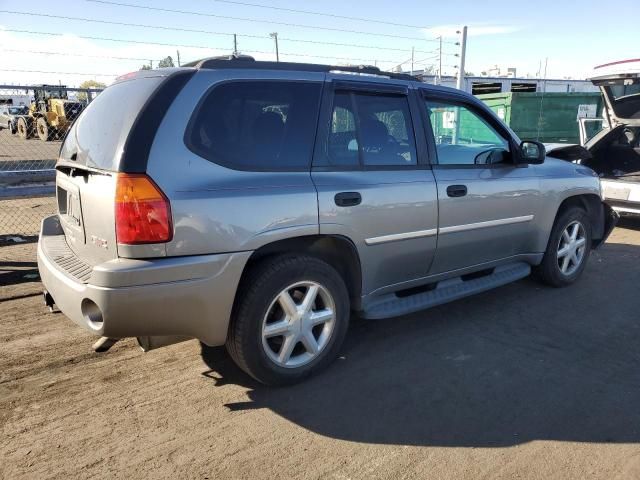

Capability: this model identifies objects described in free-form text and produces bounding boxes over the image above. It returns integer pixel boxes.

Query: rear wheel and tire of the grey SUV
[226,255,350,385]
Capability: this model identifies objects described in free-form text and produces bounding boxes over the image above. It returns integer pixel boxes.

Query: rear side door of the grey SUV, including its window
[312,78,438,295]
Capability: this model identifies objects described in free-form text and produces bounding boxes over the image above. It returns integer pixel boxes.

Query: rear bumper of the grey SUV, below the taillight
[38,215,251,346]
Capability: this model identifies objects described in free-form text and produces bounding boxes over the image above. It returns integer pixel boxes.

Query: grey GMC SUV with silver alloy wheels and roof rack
[38,57,617,384]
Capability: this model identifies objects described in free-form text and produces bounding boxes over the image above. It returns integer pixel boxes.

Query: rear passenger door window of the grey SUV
[328,92,417,167]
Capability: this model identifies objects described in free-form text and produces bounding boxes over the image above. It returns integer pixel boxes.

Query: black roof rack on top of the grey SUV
[182,55,420,81]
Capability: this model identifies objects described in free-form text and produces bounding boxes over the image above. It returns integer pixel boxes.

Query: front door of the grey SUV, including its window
[422,92,540,274]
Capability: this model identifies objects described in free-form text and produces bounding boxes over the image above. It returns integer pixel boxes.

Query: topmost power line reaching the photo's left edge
[0,10,448,54]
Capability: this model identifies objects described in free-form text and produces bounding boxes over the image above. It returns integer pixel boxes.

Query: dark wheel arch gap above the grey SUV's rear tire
[240,235,362,310]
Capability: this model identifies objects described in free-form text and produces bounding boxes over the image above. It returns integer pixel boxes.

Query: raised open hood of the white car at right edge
[590,58,640,127]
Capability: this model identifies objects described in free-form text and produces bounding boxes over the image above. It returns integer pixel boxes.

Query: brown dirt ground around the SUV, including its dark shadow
[0,221,640,480]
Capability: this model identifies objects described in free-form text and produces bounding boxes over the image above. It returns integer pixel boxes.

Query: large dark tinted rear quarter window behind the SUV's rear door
[188,81,321,170]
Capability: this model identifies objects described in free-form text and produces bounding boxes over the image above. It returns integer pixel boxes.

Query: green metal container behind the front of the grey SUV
[477,92,603,143]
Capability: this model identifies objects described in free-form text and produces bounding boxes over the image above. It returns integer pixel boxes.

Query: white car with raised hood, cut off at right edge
[549,60,640,215]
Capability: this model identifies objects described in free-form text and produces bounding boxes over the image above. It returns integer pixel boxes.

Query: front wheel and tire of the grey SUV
[534,207,592,287]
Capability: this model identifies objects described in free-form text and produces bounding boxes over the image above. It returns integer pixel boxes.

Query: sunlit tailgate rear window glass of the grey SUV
[60,77,166,171]
